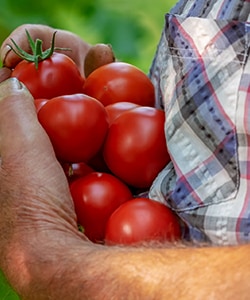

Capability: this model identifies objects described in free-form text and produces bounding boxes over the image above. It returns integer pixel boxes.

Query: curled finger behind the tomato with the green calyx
[0,24,91,74]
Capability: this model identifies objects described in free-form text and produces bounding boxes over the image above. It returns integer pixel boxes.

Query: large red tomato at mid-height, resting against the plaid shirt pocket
[103,107,170,188]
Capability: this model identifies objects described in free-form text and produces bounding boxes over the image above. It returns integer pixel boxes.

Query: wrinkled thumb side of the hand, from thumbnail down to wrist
[0,78,87,299]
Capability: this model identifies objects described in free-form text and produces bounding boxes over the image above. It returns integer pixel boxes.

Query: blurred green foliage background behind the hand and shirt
[0,0,177,300]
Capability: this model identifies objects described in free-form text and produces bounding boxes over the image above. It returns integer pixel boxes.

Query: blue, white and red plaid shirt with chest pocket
[149,0,250,245]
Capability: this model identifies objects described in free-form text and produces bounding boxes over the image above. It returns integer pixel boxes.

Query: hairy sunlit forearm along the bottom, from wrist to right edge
[3,237,250,300]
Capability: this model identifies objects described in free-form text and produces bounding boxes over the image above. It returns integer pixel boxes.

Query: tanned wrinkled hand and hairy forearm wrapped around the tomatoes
[0,25,250,300]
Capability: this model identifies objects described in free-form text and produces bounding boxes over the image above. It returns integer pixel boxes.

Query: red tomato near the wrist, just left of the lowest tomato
[70,172,133,242]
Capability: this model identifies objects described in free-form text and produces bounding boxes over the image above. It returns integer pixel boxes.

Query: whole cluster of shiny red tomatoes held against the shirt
[12,33,181,245]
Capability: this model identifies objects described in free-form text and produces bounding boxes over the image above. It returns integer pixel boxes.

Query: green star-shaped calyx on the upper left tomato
[9,30,70,69]
